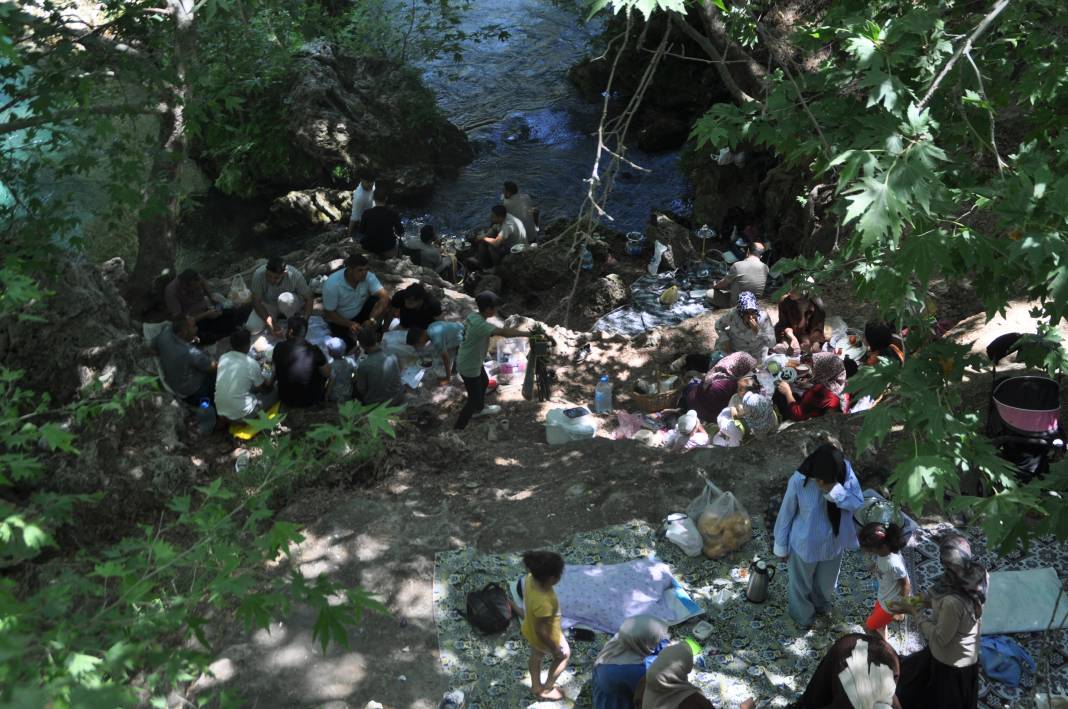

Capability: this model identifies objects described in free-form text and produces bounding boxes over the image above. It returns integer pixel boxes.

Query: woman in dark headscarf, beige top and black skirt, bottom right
[897,533,989,709]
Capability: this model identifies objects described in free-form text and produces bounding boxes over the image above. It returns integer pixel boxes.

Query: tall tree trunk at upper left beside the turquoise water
[126,0,194,314]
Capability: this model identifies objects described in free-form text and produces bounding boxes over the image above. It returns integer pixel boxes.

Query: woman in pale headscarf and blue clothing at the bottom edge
[593,615,668,709]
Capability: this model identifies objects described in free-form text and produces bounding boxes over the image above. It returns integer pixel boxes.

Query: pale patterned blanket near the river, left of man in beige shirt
[594,273,714,337]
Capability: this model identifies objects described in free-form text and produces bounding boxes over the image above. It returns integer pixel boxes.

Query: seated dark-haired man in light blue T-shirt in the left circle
[323,253,390,348]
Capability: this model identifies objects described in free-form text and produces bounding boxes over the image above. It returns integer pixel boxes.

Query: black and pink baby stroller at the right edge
[986,332,1065,483]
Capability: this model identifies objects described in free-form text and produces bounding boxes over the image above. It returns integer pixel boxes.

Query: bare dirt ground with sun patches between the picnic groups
[187,245,1063,709]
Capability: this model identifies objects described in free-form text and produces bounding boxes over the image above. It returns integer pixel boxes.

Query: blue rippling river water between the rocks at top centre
[412,0,690,231]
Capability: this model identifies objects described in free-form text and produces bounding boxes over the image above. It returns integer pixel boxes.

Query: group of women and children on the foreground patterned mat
[517,441,989,709]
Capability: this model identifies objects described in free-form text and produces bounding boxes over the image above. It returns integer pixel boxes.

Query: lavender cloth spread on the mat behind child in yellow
[509,558,704,635]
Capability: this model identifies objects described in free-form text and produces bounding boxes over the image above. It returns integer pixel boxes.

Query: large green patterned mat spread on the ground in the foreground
[434,518,921,709]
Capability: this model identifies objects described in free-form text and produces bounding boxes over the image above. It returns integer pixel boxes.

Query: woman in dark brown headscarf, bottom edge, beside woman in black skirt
[788,633,901,709]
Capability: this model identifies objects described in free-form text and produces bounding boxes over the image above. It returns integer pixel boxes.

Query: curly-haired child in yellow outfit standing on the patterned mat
[522,551,571,699]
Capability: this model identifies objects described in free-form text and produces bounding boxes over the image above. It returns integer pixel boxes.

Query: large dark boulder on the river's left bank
[277,42,474,196]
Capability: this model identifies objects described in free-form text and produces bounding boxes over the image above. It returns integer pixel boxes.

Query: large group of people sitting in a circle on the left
[153,248,480,422]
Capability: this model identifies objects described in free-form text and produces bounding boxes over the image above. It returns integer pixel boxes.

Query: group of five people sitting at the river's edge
[348,175,540,278]
